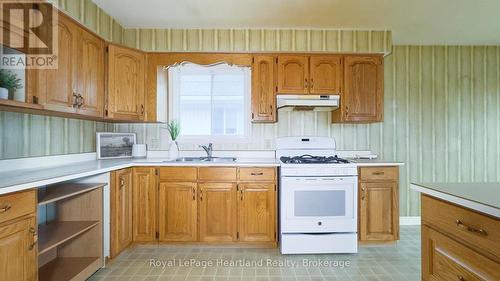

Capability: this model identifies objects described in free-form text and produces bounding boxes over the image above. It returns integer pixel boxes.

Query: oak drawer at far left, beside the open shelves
[0,190,36,223]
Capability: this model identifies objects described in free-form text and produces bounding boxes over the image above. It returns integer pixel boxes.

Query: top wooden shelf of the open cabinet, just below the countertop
[38,183,106,205]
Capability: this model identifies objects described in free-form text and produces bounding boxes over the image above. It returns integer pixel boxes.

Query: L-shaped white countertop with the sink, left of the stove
[0,158,279,194]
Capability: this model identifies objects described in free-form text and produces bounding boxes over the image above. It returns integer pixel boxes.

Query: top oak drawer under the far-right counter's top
[422,195,500,260]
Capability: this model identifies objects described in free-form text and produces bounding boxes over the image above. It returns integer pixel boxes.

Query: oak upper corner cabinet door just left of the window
[107,45,146,121]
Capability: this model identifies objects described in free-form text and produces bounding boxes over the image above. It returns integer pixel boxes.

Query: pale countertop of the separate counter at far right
[411,183,500,218]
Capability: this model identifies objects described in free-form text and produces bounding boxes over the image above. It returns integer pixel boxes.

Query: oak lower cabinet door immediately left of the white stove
[238,183,276,242]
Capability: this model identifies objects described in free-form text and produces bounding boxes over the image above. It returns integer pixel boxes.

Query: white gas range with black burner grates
[276,137,358,254]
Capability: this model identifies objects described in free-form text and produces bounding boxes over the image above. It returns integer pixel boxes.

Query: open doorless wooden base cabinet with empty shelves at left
[38,183,105,281]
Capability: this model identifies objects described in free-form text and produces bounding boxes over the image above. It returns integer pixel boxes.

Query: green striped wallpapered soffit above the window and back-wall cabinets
[123,29,392,54]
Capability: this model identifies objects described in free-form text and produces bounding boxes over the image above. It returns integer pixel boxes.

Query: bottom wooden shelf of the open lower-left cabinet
[38,257,102,281]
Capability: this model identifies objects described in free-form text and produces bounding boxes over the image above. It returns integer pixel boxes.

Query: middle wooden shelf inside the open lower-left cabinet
[38,221,99,255]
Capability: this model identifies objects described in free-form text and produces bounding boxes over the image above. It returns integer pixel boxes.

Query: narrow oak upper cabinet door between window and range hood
[252,56,276,122]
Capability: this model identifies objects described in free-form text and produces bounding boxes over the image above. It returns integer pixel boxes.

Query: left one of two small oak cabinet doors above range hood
[278,55,309,94]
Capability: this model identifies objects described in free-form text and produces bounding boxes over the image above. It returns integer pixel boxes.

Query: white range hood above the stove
[277,94,340,111]
